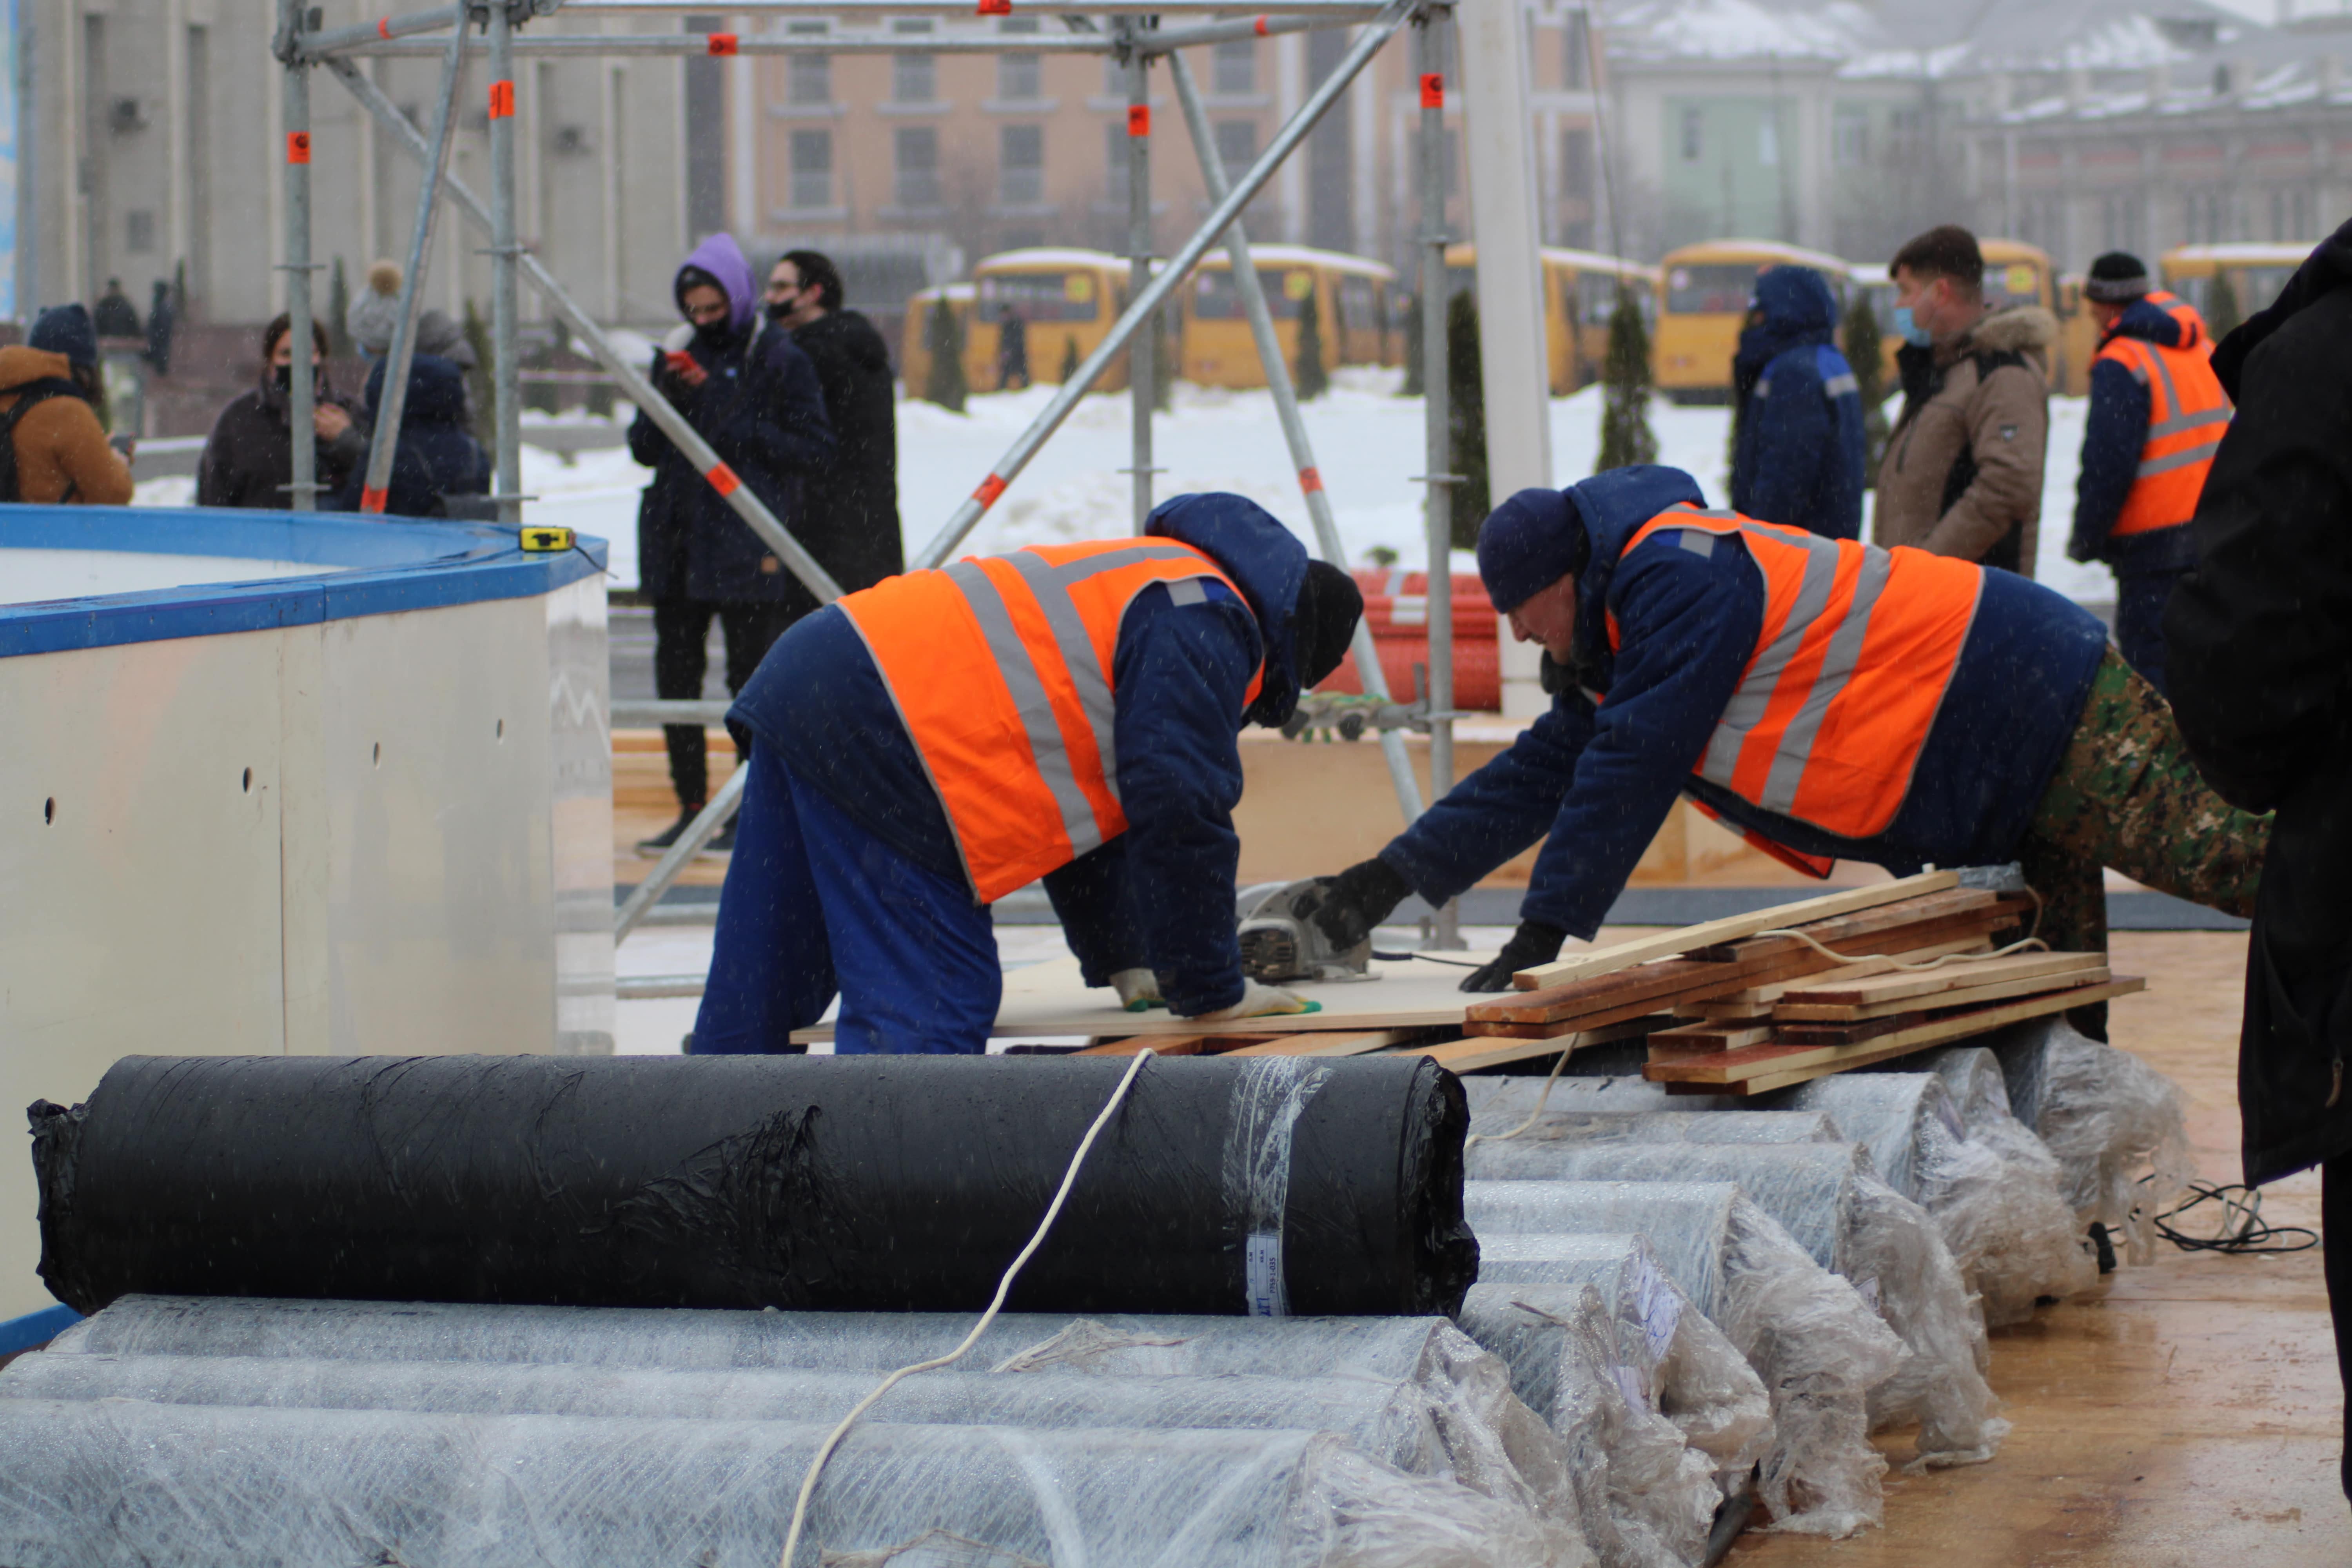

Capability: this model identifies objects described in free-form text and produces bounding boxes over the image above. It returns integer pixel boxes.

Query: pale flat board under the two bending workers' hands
[793,952,1494,1044]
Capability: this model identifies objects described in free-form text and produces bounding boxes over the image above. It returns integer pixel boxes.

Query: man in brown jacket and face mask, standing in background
[1870,223,2058,576]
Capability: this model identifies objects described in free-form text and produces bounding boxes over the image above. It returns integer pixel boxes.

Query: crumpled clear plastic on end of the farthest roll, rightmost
[1985,1018,2197,1262]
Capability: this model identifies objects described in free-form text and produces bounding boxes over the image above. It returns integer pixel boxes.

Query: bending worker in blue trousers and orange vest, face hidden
[689,496,1364,1053]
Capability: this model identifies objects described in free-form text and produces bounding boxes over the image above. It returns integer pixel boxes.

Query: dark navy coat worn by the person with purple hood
[628,318,833,611]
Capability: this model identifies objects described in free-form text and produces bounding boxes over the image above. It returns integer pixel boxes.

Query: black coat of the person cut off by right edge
[2164,223,2352,1182]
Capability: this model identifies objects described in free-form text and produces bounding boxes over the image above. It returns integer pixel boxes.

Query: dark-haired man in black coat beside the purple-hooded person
[767,252,906,592]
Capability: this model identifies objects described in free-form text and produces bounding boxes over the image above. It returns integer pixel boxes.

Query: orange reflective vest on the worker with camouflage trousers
[1609,505,1985,839]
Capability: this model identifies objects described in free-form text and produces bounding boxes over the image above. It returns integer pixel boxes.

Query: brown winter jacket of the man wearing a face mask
[1870,306,2058,576]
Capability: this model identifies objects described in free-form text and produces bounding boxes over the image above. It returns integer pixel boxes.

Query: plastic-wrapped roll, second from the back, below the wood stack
[1778,1067,2098,1326]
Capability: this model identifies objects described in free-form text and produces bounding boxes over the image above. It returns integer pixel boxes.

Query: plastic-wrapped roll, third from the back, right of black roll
[1465,1143,2009,1465]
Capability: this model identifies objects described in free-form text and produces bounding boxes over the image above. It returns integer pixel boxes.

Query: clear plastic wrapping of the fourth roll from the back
[1463,1182,1905,1535]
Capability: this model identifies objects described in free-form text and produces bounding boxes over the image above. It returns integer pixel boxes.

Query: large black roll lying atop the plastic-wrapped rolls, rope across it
[31,1056,1477,1314]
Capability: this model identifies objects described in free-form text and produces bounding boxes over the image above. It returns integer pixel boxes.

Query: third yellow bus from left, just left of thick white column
[1176,245,1397,388]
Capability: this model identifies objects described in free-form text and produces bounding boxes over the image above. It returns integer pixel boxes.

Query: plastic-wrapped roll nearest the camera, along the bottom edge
[0,1399,1592,1568]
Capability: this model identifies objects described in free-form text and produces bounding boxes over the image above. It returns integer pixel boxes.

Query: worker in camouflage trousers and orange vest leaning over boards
[1315,468,2263,1006]
